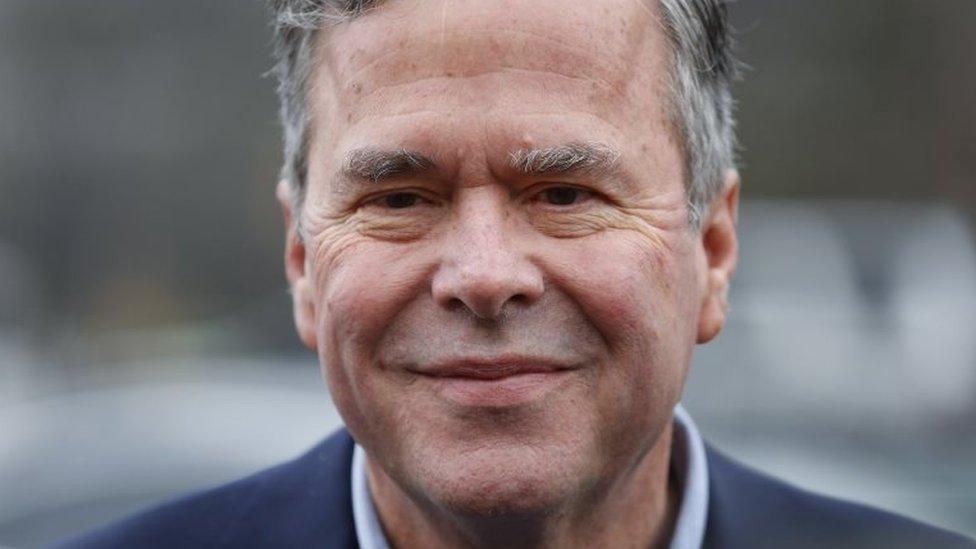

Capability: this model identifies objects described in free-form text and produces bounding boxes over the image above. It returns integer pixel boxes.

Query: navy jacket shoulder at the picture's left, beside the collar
[55,430,356,549]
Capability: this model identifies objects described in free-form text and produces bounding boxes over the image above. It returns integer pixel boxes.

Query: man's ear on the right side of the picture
[698,170,739,343]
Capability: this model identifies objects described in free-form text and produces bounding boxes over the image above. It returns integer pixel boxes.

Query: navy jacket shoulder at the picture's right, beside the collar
[704,446,976,549]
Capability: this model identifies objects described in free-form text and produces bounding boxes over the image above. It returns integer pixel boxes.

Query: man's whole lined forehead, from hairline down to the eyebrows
[310,0,669,170]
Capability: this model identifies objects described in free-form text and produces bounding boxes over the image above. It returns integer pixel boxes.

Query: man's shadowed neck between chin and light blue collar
[366,424,679,549]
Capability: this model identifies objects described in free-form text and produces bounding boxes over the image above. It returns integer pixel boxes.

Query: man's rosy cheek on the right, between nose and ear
[550,227,699,390]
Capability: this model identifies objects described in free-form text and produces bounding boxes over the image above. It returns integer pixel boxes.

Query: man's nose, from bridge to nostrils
[431,192,544,320]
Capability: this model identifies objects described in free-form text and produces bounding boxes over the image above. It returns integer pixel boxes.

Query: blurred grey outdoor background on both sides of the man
[0,0,976,547]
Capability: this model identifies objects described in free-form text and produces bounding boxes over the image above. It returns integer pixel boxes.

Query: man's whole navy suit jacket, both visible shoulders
[59,430,976,549]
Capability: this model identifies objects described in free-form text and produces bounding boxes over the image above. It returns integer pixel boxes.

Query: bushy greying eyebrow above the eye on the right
[509,142,620,175]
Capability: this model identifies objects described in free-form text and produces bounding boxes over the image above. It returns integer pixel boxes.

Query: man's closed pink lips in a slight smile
[415,356,574,408]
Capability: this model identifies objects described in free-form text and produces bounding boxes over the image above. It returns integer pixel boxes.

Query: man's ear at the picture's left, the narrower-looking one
[275,180,317,351]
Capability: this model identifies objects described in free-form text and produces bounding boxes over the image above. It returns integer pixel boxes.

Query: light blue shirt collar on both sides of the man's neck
[351,404,708,549]
